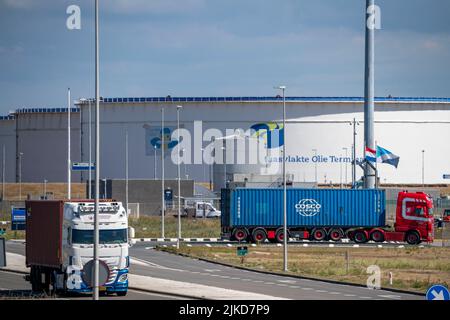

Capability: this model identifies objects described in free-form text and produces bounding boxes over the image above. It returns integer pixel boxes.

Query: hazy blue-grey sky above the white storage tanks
[0,0,450,114]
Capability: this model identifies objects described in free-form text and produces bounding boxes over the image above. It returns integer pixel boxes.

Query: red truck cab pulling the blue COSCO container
[386,191,434,244]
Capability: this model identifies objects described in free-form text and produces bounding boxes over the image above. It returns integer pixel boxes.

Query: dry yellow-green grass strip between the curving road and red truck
[159,246,450,292]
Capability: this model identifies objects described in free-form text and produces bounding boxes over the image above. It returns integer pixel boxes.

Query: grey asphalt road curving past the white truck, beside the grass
[0,242,424,300]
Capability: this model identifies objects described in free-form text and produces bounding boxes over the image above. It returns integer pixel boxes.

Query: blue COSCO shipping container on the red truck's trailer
[222,188,386,228]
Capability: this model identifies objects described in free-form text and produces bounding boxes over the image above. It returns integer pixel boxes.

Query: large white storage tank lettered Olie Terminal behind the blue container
[72,97,450,184]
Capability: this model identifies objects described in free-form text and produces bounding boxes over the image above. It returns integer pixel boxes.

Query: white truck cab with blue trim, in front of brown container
[62,201,134,296]
